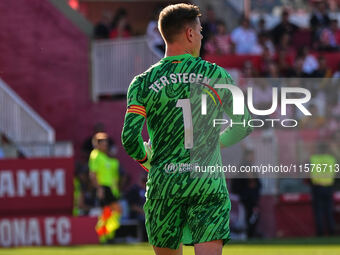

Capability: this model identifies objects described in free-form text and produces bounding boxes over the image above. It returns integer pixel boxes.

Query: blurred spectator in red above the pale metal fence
[110,8,131,39]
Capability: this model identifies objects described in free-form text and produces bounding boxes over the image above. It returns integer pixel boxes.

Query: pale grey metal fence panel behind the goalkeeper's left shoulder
[92,37,159,101]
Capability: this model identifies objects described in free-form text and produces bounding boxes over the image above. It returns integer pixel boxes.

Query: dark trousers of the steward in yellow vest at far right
[312,185,335,236]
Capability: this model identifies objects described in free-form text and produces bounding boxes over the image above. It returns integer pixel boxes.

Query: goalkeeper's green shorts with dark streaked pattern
[144,194,231,249]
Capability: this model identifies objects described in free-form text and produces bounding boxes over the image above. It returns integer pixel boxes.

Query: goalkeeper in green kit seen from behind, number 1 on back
[122,4,252,255]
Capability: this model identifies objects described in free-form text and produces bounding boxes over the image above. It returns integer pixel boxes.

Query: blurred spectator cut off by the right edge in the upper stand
[318,20,339,51]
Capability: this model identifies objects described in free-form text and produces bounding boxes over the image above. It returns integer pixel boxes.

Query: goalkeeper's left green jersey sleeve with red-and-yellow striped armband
[121,78,147,163]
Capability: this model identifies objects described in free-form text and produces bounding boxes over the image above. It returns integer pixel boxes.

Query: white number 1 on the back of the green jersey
[176,99,194,149]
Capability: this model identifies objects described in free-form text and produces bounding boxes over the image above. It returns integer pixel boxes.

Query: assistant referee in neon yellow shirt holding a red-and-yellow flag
[89,132,121,242]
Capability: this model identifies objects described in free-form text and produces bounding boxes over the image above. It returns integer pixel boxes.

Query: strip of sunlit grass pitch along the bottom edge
[0,238,340,255]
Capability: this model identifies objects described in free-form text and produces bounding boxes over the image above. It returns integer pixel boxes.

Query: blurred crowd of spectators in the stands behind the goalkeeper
[94,1,340,138]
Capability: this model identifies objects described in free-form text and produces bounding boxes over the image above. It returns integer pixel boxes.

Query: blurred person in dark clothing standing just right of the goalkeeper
[232,150,261,238]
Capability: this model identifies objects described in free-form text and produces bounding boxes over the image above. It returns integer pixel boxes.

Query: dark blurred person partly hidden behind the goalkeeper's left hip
[126,172,147,241]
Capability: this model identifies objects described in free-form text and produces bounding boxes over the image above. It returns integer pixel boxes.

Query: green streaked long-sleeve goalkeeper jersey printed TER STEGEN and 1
[122,54,251,198]
